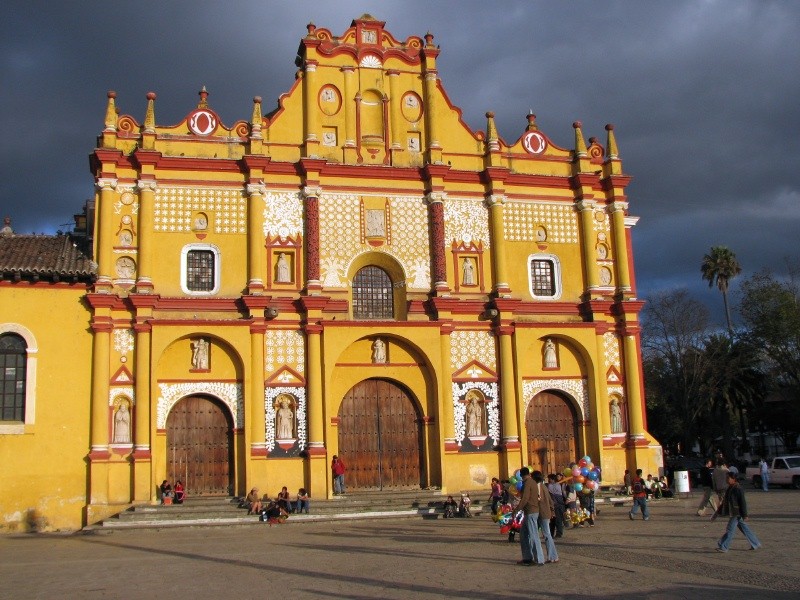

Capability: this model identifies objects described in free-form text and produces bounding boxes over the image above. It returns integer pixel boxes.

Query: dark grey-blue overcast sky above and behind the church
[0,0,800,323]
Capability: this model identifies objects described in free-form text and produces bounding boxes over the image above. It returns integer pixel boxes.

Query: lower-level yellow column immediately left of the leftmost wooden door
[133,317,156,502]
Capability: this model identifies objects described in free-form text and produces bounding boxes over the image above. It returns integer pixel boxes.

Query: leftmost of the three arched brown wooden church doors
[167,396,233,496]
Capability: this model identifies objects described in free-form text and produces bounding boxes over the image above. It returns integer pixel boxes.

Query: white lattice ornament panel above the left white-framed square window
[153,187,247,234]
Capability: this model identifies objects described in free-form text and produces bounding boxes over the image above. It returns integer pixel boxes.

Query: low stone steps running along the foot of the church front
[84,490,489,531]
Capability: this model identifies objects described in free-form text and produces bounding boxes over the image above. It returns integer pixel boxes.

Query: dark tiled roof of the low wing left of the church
[0,235,97,281]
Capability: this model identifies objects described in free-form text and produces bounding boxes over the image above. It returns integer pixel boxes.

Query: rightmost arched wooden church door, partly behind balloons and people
[525,392,578,475]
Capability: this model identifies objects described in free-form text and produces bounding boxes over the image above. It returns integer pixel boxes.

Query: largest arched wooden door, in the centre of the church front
[339,379,423,489]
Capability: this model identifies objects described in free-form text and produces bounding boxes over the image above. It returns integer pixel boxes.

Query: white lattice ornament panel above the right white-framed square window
[503,202,578,244]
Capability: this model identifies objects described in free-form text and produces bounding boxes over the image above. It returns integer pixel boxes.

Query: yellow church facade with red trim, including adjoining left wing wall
[0,15,661,529]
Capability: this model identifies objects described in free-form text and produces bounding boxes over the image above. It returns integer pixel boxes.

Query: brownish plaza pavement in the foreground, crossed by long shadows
[0,486,800,600]
